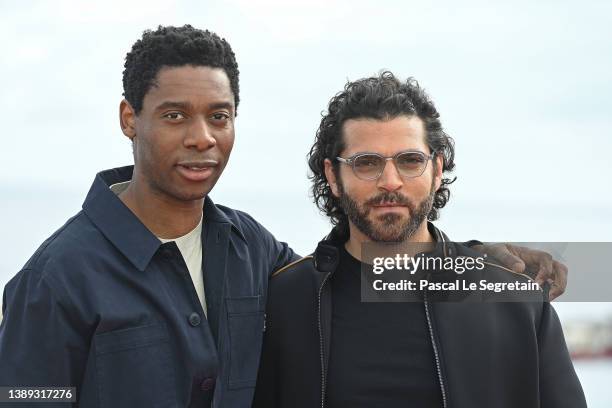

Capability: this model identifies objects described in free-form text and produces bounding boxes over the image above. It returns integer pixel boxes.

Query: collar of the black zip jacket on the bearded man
[313,221,457,272]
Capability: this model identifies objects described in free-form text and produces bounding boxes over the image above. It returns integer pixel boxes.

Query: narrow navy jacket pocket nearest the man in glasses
[226,296,264,389]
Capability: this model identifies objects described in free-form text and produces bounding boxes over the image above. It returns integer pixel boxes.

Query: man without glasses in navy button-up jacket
[0,25,572,408]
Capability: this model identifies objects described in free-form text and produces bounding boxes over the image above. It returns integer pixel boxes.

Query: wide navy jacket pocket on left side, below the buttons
[94,324,176,408]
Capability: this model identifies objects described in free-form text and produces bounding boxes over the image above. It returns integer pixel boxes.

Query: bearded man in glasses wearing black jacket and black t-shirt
[254,72,586,408]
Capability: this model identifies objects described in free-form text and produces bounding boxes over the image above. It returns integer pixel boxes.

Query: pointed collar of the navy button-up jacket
[83,166,244,271]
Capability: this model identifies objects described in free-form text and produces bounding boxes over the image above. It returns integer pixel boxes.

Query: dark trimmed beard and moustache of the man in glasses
[338,180,436,243]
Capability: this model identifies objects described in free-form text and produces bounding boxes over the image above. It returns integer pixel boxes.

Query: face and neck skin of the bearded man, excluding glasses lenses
[325,115,442,259]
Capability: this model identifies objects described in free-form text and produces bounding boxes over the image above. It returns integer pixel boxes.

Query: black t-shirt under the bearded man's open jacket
[327,247,442,408]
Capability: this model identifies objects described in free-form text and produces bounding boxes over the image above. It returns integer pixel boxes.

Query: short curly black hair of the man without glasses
[123,24,240,114]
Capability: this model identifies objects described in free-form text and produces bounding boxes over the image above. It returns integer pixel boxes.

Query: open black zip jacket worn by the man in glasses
[254,226,586,408]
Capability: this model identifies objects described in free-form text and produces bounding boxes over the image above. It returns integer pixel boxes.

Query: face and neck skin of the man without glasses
[119,66,235,239]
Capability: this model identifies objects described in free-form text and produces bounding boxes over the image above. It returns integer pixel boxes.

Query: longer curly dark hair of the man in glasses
[307,71,456,234]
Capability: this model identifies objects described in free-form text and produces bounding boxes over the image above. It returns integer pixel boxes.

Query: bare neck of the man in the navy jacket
[119,178,204,239]
